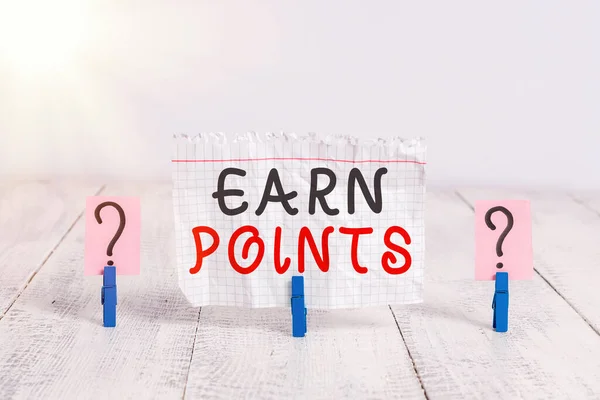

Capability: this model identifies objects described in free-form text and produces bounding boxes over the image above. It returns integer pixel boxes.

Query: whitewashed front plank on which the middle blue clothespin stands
[186,307,424,399]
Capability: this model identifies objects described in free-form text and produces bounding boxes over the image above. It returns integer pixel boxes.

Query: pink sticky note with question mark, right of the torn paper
[475,200,533,280]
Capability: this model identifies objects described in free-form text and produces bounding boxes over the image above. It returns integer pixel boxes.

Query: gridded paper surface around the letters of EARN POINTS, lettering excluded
[173,141,425,309]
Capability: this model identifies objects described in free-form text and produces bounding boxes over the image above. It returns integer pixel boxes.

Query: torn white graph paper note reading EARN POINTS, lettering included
[172,134,425,309]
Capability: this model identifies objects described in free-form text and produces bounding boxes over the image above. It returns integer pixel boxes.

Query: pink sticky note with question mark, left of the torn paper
[85,196,141,275]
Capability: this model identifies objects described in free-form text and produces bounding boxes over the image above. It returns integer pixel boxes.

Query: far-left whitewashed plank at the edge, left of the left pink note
[0,181,101,318]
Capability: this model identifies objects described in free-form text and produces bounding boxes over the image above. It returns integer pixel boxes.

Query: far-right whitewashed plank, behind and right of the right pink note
[460,189,600,335]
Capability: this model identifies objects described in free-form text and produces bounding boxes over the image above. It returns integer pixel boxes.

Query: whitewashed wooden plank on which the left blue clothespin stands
[0,185,199,399]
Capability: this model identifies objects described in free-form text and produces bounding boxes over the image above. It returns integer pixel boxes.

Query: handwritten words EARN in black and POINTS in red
[190,167,412,275]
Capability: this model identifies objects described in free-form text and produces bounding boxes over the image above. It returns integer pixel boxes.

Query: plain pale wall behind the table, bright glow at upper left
[0,0,600,188]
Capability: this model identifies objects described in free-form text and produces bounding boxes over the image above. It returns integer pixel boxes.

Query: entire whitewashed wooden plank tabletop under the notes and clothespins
[0,181,600,399]
